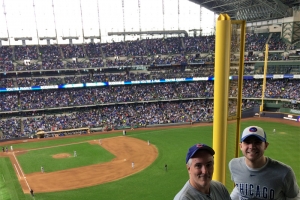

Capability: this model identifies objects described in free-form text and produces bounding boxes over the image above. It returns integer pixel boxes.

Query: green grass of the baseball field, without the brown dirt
[0,121,300,200]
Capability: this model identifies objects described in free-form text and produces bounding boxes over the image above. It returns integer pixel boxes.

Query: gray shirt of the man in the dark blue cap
[174,181,231,200]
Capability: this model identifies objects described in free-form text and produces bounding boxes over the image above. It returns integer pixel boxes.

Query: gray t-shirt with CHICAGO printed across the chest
[229,157,299,200]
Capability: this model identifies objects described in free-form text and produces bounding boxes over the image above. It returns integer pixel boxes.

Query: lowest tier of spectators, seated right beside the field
[0,99,257,139]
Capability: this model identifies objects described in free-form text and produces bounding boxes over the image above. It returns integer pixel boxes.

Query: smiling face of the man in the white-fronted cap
[240,136,268,162]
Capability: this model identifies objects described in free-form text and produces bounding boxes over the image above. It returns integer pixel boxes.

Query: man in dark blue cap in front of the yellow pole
[174,143,231,200]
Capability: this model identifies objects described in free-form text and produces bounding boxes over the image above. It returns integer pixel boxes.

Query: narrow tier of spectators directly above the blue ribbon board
[0,63,291,88]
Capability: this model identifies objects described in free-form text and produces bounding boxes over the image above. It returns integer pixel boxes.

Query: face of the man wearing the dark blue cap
[187,150,214,193]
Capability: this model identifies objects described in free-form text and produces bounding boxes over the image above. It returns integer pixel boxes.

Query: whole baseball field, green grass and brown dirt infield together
[0,118,300,200]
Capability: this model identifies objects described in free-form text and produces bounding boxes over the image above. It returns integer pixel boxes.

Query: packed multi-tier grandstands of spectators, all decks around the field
[0,33,300,139]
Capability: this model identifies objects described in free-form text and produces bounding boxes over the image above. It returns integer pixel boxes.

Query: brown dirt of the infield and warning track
[0,118,300,193]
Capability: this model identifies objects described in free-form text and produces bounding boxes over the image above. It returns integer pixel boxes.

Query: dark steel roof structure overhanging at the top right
[189,0,300,22]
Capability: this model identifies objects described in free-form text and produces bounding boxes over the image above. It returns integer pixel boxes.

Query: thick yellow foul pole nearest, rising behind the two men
[213,14,231,184]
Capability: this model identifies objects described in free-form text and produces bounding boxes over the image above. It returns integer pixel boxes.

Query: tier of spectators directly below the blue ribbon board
[0,79,300,112]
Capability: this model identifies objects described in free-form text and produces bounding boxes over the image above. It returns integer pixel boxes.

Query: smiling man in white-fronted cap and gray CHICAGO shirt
[229,126,300,200]
